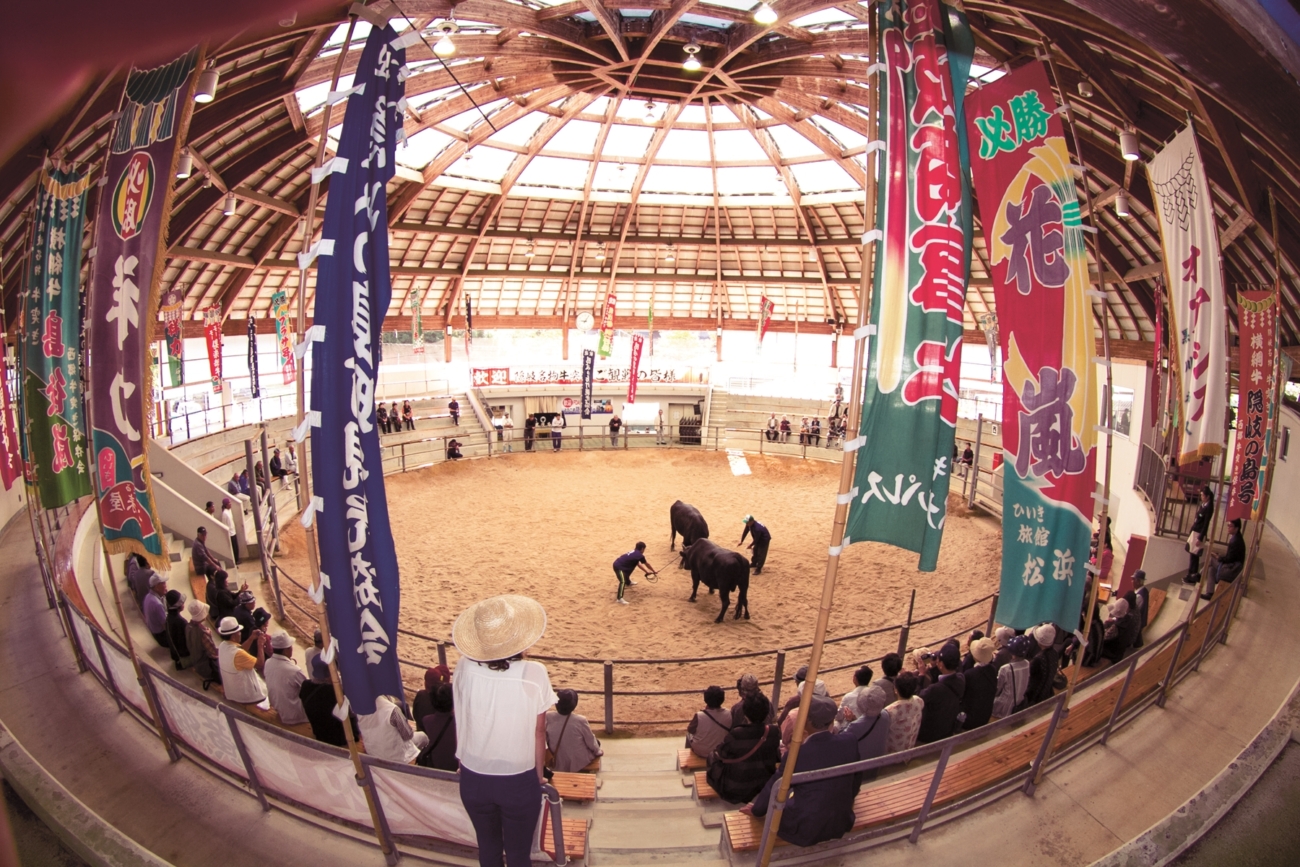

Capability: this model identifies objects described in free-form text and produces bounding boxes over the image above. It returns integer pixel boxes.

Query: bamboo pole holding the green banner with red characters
[757,4,884,867]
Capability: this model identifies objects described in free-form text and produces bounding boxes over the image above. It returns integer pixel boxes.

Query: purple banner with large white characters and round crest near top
[86,51,198,569]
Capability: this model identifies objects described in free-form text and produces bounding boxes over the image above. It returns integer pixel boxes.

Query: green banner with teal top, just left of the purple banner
[21,168,90,508]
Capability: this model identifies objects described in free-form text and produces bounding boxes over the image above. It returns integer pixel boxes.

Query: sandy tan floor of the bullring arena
[278,450,1001,733]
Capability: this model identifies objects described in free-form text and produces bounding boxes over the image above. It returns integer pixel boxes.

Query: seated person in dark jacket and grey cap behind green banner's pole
[741,695,858,846]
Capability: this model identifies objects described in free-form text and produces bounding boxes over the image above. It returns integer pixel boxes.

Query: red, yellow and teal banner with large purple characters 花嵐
[966,62,1099,629]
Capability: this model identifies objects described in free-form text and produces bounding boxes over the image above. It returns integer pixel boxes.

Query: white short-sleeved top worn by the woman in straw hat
[452,659,558,776]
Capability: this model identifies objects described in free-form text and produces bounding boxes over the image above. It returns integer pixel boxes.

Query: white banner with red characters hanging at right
[1147,123,1227,465]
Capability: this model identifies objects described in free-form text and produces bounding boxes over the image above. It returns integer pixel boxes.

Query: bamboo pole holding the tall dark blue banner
[282,14,397,864]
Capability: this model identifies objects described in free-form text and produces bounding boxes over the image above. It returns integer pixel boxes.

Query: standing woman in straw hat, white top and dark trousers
[451,595,558,867]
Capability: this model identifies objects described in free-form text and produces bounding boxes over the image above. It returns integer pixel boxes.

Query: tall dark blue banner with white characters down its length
[304,26,408,714]
